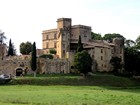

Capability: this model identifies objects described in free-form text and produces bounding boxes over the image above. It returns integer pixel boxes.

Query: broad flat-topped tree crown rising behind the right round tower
[103,33,125,42]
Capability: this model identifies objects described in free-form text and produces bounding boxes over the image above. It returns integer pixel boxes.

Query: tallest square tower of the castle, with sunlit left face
[57,18,71,58]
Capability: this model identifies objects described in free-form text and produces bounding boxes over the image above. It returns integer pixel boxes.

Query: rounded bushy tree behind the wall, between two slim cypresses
[20,41,32,55]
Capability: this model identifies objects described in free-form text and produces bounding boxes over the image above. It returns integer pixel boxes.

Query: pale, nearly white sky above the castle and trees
[0,0,140,54]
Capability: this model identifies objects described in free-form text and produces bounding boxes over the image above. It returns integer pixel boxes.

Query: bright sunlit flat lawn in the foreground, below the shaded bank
[0,85,140,105]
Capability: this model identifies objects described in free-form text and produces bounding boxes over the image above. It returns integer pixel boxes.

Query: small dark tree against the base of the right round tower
[110,57,122,75]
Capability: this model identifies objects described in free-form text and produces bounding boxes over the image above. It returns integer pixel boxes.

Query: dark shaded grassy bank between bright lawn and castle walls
[9,74,140,87]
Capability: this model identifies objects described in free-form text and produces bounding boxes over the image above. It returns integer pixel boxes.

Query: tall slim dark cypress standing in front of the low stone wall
[31,42,37,77]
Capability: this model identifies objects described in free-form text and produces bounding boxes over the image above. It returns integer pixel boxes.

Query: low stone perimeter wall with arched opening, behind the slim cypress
[0,56,70,76]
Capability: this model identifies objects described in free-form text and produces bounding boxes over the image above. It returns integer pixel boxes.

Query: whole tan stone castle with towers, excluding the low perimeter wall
[42,18,124,71]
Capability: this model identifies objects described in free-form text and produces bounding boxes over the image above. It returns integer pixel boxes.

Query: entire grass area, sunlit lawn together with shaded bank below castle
[0,75,140,105]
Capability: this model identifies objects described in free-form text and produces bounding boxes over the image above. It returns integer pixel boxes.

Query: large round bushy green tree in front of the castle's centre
[74,50,92,75]
